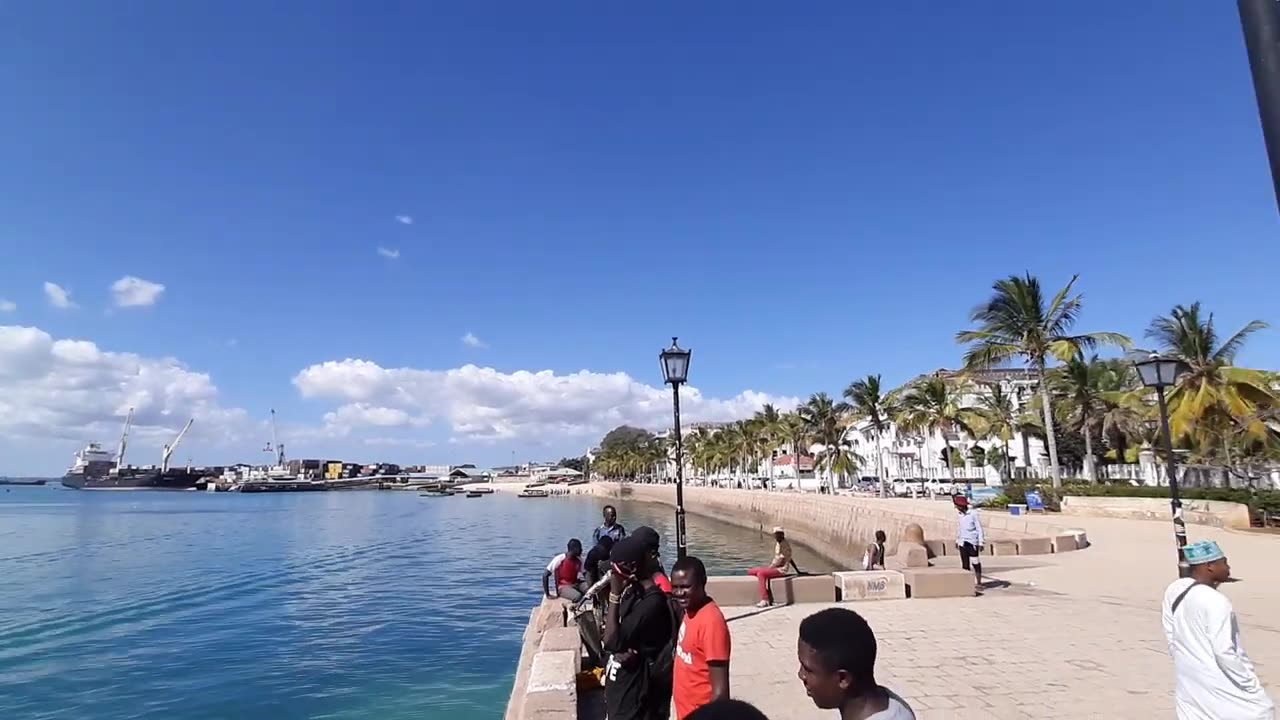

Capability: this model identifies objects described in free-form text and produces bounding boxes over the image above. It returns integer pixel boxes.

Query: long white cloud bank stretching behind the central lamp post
[293,359,799,441]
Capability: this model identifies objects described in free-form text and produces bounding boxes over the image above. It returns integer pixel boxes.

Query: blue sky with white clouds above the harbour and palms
[0,1,1280,473]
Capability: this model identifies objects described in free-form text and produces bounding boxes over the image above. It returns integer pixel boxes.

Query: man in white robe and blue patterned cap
[1161,541,1275,720]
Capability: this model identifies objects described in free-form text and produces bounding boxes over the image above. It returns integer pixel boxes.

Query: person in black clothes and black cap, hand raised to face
[604,537,676,720]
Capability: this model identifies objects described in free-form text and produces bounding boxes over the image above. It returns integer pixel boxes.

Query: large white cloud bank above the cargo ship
[0,325,256,450]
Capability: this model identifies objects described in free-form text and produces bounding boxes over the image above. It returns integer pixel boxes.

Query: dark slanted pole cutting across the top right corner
[1236,0,1280,209]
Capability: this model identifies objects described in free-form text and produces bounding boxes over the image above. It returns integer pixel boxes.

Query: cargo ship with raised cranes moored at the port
[63,409,206,489]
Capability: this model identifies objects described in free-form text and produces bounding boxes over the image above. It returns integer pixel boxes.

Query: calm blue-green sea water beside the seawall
[0,487,827,720]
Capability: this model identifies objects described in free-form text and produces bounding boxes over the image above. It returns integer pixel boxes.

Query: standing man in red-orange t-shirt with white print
[671,556,731,720]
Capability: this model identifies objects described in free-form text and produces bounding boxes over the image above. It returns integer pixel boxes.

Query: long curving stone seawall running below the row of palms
[586,483,1088,568]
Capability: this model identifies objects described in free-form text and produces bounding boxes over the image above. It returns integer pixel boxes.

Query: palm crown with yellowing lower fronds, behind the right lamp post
[1147,302,1276,445]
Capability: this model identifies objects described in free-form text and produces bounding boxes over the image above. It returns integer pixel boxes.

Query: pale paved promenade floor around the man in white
[604,489,1280,720]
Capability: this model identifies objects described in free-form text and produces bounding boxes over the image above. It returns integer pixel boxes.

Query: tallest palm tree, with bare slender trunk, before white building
[956,273,1132,487]
